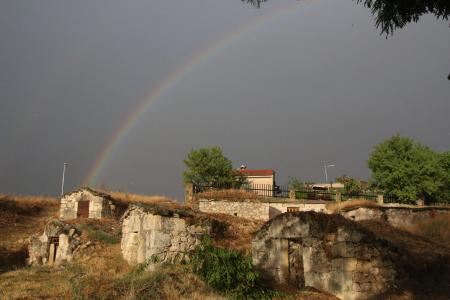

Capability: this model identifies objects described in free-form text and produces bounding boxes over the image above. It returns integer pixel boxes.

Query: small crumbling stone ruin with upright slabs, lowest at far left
[28,220,81,265]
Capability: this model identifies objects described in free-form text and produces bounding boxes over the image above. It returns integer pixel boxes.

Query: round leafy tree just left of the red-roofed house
[183,147,238,187]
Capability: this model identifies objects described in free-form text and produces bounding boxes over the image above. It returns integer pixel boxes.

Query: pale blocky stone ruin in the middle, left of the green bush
[121,204,214,264]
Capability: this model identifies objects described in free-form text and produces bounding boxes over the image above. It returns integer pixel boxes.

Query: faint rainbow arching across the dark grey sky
[83,1,306,185]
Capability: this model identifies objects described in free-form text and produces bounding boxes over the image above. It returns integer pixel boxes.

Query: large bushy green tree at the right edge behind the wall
[368,134,450,202]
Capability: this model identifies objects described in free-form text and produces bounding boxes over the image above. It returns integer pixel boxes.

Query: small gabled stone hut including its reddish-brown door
[60,188,125,220]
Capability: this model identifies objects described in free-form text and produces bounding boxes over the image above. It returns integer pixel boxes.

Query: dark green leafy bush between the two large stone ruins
[190,236,276,299]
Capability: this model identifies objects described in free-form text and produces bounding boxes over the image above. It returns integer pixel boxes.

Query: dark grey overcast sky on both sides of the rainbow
[0,0,450,199]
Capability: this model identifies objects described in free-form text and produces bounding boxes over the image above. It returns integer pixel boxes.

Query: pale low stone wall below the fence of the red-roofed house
[198,199,269,221]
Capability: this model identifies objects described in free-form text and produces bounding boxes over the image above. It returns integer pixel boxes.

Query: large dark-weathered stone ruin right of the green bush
[252,212,398,300]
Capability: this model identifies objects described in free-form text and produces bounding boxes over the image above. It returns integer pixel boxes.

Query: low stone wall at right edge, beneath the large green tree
[341,207,450,227]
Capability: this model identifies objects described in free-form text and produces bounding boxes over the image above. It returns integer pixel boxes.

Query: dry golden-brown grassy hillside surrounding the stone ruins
[0,192,450,300]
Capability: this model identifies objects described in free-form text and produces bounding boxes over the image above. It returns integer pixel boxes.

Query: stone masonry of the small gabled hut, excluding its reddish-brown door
[60,188,117,220]
